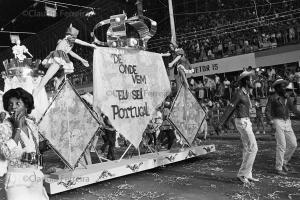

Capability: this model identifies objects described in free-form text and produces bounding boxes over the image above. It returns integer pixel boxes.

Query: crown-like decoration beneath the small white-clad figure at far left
[1,58,44,78]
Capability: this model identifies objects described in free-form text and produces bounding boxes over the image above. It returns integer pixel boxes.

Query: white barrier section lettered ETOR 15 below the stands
[187,53,256,77]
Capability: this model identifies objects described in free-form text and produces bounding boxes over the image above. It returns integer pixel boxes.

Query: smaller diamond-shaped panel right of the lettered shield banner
[169,87,206,144]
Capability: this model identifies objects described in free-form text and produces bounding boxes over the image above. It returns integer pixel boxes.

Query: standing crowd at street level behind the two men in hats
[189,63,300,134]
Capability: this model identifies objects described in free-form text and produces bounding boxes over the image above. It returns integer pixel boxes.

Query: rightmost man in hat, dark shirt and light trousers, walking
[266,78,300,175]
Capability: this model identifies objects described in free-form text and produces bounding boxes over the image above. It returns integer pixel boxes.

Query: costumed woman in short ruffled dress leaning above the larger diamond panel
[33,24,97,96]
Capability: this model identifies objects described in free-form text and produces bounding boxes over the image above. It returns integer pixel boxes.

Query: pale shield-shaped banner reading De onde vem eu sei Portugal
[93,47,171,147]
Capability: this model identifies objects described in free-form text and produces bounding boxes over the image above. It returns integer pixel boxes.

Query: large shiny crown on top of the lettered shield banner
[92,14,157,50]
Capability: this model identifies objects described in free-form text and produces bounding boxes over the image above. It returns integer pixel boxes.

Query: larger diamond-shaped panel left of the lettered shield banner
[39,81,99,168]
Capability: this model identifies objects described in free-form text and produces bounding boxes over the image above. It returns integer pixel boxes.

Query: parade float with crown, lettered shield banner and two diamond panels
[1,11,215,194]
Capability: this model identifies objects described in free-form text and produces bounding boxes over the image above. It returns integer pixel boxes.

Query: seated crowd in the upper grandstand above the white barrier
[149,0,300,63]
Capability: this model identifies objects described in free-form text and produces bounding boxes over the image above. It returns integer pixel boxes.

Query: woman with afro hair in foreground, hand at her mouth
[0,88,49,200]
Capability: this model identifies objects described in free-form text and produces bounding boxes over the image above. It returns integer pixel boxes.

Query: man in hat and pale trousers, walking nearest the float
[221,70,259,184]
